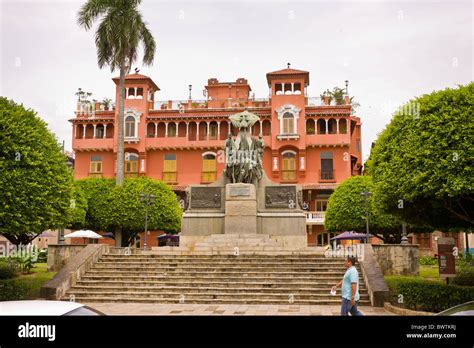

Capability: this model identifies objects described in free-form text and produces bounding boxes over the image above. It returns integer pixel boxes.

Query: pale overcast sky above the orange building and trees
[0,0,473,159]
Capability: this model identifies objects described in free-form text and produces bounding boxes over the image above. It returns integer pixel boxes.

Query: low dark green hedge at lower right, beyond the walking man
[386,277,474,312]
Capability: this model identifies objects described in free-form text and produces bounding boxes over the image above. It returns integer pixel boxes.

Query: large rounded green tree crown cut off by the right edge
[370,83,474,230]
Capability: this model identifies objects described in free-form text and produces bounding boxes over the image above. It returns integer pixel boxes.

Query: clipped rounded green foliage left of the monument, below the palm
[78,177,181,246]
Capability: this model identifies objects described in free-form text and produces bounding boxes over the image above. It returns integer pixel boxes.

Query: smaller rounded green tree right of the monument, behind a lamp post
[324,176,401,243]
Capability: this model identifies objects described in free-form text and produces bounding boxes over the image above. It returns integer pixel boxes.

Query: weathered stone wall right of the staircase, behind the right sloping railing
[372,244,419,276]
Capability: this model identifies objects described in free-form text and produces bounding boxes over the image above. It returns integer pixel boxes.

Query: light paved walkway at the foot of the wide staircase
[86,303,395,315]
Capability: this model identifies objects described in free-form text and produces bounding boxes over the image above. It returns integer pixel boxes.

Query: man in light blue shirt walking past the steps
[332,256,363,316]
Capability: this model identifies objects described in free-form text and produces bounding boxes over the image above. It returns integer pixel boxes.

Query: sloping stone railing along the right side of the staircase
[359,244,390,307]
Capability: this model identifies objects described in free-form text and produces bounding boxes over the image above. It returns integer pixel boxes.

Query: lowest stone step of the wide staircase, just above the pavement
[65,296,370,306]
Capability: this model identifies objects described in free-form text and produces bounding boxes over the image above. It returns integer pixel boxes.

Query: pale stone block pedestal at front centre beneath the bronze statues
[224,184,258,234]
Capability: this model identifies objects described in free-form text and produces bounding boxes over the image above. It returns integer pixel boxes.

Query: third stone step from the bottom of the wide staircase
[77,279,365,290]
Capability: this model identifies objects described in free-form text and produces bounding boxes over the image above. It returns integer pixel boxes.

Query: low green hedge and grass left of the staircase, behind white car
[0,263,56,301]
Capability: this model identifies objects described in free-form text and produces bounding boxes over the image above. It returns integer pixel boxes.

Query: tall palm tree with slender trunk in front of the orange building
[77,0,156,185]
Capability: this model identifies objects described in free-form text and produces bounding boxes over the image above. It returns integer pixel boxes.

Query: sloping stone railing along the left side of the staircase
[40,244,109,300]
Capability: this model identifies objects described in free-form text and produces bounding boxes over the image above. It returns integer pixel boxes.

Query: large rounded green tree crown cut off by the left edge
[0,98,72,244]
